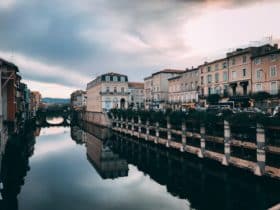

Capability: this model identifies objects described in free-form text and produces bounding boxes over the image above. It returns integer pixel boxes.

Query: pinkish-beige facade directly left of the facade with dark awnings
[198,58,228,96]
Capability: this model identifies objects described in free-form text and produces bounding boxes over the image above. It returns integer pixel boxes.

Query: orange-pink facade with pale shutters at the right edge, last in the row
[252,50,280,95]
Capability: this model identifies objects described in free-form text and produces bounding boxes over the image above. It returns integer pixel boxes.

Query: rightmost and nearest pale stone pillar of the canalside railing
[254,123,266,176]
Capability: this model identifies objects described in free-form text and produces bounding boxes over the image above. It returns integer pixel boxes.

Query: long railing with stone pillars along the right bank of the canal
[112,116,280,179]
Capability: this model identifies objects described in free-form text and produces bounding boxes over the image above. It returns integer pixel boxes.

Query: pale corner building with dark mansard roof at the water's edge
[86,72,129,112]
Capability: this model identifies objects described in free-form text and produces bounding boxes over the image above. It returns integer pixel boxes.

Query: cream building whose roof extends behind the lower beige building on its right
[144,69,184,109]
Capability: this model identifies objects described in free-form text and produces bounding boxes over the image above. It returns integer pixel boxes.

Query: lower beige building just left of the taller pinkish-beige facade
[168,68,199,109]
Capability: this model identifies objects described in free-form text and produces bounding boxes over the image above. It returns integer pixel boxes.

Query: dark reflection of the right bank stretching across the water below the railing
[72,124,280,210]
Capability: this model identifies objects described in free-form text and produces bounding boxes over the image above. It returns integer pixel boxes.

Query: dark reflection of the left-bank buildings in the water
[0,126,37,210]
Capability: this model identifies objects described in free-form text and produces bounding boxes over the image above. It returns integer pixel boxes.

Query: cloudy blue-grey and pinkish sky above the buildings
[0,0,280,98]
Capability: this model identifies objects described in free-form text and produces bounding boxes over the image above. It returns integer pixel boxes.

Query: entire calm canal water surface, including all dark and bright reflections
[0,120,280,210]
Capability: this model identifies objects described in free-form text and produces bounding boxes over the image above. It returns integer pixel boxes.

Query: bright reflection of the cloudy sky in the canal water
[19,128,188,210]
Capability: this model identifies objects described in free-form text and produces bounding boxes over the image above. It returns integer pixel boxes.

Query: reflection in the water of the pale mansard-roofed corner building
[71,124,128,179]
